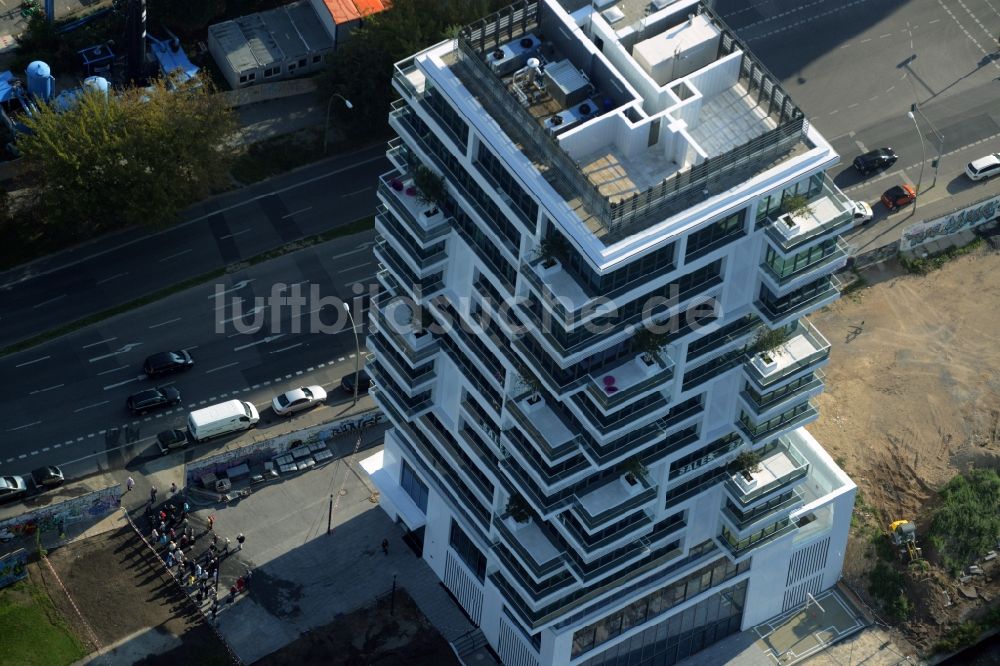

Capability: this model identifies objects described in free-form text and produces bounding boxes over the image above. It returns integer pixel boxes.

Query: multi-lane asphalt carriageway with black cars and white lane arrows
[0,231,375,473]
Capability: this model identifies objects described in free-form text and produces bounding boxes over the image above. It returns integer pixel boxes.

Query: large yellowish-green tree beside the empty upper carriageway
[18,81,236,232]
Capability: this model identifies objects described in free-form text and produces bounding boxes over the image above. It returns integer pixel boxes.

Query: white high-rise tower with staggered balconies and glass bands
[366,0,855,666]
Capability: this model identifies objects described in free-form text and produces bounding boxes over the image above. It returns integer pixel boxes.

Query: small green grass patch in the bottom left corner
[0,577,89,666]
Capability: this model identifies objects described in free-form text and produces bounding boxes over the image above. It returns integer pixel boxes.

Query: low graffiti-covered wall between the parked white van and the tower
[185,409,385,486]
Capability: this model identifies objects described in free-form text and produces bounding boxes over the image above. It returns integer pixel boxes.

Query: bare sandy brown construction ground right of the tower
[809,243,1000,654]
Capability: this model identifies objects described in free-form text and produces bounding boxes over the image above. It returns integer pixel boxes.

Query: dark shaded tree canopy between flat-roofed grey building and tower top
[318,0,510,137]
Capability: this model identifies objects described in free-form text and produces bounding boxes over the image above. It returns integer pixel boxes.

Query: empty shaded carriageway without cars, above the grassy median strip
[0,145,391,346]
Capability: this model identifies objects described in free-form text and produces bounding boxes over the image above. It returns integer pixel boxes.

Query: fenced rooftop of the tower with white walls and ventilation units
[448,2,808,244]
